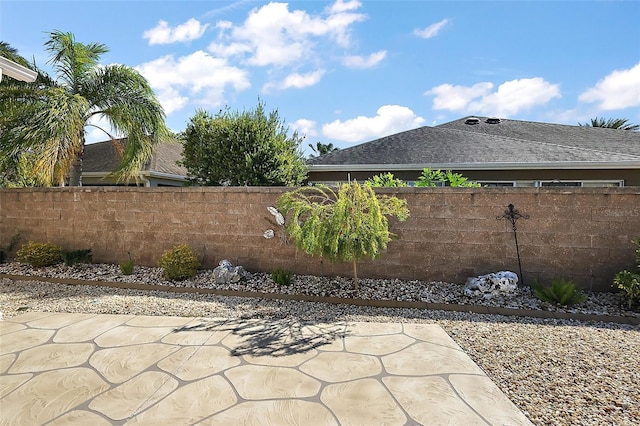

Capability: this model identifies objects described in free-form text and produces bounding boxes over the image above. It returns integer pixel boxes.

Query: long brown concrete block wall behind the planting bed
[0,187,640,291]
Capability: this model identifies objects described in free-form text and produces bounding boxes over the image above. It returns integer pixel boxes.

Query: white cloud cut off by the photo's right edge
[578,62,640,111]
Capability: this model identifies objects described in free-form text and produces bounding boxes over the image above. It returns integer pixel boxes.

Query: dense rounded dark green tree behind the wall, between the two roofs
[182,101,307,186]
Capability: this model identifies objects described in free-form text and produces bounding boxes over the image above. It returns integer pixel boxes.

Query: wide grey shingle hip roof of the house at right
[309,117,640,171]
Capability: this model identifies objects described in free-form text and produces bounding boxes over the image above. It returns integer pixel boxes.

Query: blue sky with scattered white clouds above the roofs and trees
[0,0,640,155]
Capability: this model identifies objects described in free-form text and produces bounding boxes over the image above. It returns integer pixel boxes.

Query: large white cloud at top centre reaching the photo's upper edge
[209,0,365,66]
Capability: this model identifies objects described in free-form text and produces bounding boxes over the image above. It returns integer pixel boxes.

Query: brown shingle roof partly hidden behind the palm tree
[82,140,187,185]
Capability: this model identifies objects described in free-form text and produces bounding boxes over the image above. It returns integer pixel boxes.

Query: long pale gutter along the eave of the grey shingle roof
[308,161,640,172]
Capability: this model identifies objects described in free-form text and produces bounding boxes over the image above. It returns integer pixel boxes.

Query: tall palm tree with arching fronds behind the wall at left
[0,31,171,186]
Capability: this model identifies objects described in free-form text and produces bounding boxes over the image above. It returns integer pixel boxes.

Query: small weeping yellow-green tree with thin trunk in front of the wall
[277,181,409,290]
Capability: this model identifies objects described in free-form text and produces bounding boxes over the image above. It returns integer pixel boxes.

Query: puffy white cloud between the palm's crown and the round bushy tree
[136,51,251,114]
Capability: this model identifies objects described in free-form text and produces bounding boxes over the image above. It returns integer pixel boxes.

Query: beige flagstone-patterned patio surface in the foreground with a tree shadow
[0,312,531,426]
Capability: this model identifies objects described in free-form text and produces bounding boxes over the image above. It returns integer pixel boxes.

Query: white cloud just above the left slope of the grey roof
[322,105,424,142]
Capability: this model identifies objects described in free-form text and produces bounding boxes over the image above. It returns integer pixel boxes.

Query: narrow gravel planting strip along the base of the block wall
[0,262,640,317]
